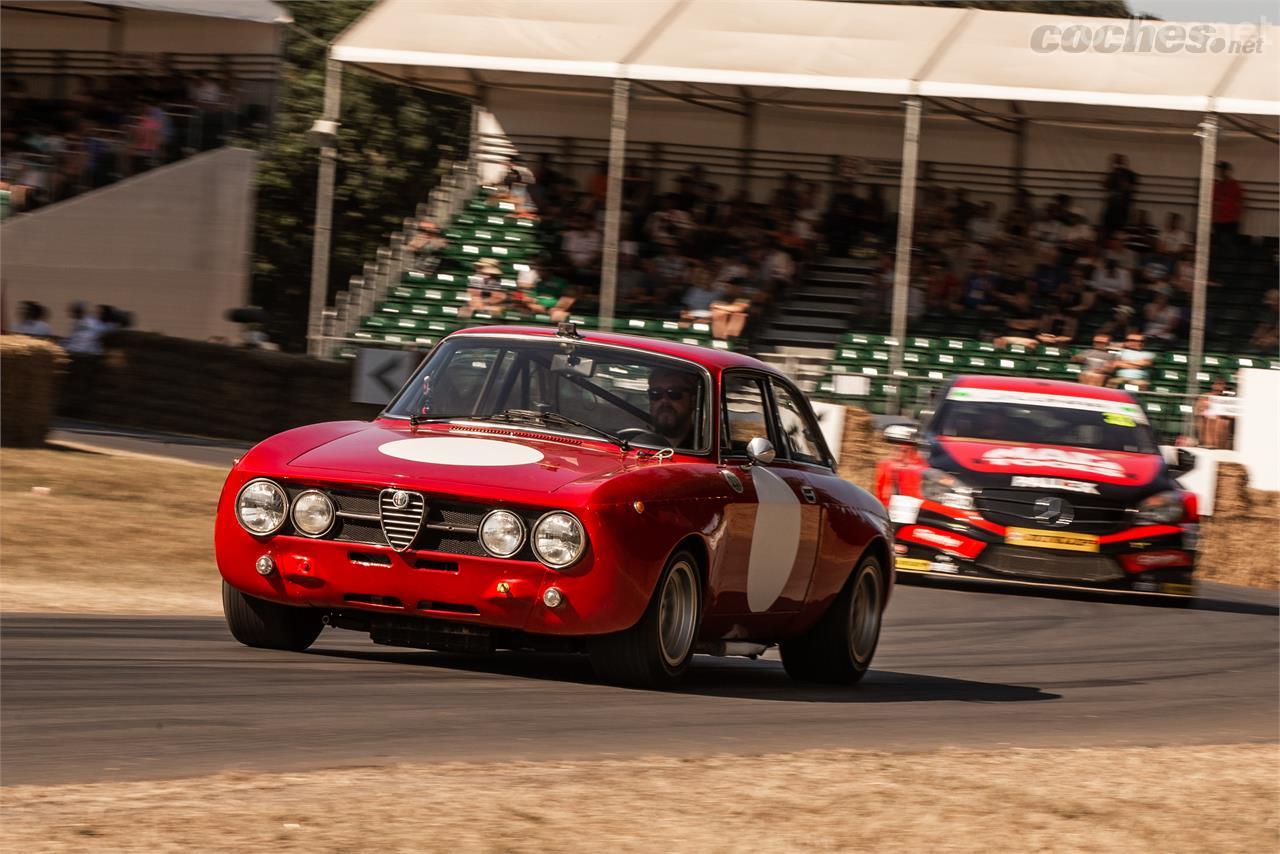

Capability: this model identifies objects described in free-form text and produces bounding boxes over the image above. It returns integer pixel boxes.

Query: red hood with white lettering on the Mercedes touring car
[938,437,1164,487]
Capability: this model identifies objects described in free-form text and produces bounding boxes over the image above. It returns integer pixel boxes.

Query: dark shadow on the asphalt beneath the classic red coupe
[306,648,1061,703]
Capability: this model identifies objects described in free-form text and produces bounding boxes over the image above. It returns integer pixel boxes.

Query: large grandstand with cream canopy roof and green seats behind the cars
[312,0,1280,448]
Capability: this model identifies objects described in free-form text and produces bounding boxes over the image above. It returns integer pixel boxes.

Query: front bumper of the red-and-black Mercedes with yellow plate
[895,502,1198,598]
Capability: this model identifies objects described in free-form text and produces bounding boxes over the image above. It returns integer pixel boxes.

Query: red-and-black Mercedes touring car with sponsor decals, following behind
[877,376,1199,598]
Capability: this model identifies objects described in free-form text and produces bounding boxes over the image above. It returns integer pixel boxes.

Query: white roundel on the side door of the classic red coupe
[746,466,800,612]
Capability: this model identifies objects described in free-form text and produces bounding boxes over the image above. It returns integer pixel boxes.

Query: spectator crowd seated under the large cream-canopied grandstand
[411,148,1275,363]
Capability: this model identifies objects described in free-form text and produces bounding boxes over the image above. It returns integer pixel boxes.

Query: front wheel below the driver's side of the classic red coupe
[588,552,703,688]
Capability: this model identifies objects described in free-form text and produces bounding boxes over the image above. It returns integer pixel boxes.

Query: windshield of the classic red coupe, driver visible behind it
[387,335,709,453]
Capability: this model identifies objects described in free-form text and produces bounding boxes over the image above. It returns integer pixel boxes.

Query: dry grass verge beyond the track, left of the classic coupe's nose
[0,448,227,613]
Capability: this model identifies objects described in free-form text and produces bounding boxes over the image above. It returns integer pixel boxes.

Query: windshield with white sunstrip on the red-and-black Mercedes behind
[929,388,1158,453]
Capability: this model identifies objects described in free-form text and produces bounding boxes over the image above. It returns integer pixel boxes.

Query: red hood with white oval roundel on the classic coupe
[289,424,625,495]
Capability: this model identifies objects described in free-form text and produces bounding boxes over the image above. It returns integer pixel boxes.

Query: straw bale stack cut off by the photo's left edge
[0,335,69,447]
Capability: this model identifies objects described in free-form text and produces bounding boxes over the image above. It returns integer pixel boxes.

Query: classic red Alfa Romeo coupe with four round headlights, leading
[215,324,893,685]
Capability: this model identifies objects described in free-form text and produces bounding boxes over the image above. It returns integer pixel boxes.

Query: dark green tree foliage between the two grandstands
[253,0,470,350]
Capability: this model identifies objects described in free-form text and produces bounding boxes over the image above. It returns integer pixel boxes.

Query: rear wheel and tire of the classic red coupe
[781,557,884,685]
